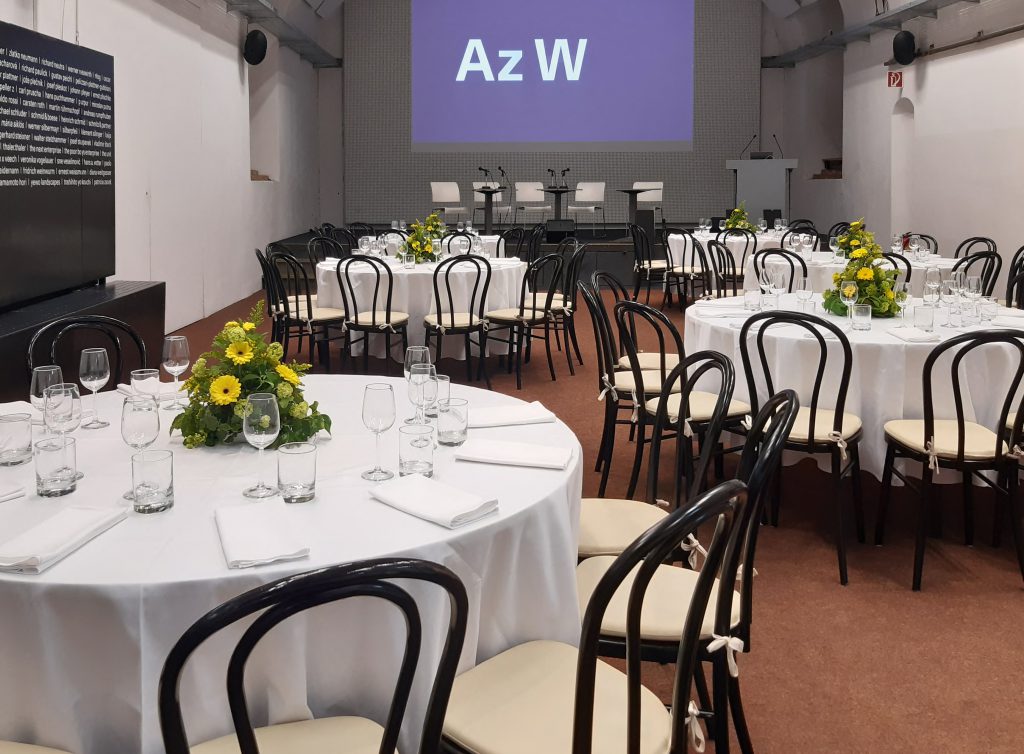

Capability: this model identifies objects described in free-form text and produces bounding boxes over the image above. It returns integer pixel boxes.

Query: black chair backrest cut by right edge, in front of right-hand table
[922,330,1024,463]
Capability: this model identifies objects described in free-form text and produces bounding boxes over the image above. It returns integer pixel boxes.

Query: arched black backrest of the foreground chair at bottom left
[158,557,468,754]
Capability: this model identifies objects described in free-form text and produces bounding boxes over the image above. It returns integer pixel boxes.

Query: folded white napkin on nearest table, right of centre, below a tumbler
[370,474,498,529]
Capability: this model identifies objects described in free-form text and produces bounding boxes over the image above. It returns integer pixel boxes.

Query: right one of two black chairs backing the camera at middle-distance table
[423,254,490,388]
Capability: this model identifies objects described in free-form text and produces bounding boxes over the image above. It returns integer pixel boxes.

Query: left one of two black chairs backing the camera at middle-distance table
[335,254,409,373]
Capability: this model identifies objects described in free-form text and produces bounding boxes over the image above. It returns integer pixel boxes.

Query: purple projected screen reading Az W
[412,0,694,152]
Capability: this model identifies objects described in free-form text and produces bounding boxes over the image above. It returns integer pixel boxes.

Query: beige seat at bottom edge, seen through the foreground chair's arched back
[190,717,384,754]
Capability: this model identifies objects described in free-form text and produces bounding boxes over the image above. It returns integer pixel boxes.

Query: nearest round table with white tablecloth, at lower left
[0,376,582,754]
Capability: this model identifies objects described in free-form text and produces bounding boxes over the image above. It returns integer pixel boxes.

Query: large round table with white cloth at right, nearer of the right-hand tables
[684,294,1024,483]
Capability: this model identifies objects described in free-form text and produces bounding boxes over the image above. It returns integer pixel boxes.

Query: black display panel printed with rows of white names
[0,23,114,309]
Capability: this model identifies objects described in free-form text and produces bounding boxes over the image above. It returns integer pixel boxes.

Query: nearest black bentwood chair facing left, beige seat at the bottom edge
[438,481,746,754]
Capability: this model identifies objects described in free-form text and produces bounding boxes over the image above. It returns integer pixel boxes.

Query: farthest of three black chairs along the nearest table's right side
[578,351,735,559]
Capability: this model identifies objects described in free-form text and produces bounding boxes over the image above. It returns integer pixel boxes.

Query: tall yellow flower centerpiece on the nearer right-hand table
[823,219,906,317]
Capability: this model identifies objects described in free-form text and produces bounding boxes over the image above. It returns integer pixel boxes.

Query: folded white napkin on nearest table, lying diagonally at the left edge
[0,506,128,574]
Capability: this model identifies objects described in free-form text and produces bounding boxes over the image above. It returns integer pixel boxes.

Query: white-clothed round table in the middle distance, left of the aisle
[316,257,526,360]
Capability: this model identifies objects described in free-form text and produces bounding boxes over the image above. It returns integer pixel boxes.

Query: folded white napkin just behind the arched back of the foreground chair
[213,501,309,569]
